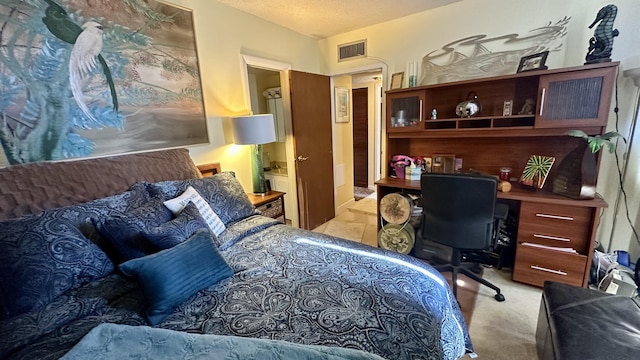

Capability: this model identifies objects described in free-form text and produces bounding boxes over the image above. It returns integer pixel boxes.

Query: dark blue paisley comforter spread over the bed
[0,215,472,359]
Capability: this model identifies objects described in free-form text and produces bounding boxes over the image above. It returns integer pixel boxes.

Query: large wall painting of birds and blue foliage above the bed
[0,0,209,166]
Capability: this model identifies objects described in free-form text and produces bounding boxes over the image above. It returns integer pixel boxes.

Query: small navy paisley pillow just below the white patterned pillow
[142,202,211,250]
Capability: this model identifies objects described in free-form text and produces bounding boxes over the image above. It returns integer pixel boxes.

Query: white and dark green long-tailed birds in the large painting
[42,0,118,122]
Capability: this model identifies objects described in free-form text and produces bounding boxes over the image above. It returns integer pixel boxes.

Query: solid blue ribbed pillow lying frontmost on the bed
[119,230,233,325]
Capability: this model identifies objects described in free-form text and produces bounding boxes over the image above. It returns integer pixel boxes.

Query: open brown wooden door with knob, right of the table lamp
[289,70,335,229]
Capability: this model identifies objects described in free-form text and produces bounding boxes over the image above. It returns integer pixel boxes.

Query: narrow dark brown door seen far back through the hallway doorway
[351,88,369,187]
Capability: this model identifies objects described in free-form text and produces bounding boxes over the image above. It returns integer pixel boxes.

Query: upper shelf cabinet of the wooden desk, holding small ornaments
[386,63,617,137]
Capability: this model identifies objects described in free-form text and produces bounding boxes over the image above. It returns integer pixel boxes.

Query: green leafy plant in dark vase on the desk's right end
[552,130,622,199]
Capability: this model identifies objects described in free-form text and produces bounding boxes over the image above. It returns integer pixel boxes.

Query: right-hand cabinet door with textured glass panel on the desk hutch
[536,67,616,128]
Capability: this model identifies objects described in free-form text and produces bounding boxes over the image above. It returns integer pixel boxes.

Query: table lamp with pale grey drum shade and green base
[231,114,276,195]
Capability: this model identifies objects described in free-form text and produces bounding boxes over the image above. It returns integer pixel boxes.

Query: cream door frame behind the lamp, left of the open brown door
[241,54,300,227]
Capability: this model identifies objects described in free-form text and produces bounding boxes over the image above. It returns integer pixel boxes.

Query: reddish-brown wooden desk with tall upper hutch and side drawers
[376,62,618,286]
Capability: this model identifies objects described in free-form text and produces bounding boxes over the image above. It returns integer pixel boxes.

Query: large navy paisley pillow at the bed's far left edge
[0,207,113,318]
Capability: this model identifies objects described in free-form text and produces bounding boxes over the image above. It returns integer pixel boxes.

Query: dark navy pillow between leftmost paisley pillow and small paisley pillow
[92,198,173,263]
